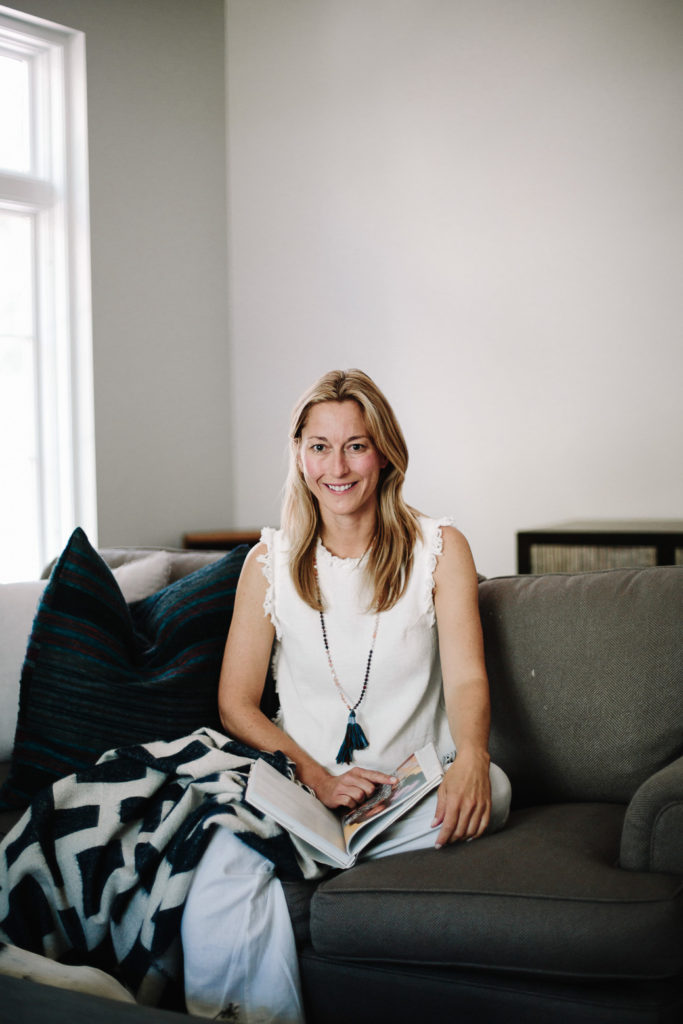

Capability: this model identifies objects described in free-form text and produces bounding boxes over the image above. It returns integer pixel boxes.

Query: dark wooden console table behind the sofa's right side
[517,519,683,572]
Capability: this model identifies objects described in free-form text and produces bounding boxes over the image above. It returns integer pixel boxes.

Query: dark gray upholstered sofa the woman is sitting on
[0,552,683,1024]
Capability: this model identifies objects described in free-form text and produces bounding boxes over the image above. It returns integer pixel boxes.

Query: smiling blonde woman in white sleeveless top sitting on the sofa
[182,370,510,1024]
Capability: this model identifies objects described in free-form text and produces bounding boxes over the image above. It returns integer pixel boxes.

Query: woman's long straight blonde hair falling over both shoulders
[282,370,421,611]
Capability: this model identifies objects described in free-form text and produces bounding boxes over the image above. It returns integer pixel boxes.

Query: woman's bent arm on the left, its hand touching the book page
[218,544,389,808]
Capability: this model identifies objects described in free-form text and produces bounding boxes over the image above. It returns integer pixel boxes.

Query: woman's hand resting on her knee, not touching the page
[432,750,490,850]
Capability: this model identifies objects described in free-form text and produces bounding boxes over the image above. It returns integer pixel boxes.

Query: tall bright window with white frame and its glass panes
[0,7,96,583]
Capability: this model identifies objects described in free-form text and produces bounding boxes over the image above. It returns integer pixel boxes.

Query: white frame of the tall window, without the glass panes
[0,5,97,566]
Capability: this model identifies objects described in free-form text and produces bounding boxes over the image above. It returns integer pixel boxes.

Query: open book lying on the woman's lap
[247,743,443,867]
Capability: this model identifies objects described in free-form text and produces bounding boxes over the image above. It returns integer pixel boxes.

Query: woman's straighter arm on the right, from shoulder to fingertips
[434,526,490,847]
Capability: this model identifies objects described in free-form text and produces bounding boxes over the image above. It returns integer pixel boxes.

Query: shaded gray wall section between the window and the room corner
[17,0,231,546]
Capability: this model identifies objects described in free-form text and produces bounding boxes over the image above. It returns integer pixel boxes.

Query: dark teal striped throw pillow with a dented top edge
[0,528,248,810]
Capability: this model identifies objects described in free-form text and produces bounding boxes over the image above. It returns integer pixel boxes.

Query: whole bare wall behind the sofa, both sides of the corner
[10,0,683,574]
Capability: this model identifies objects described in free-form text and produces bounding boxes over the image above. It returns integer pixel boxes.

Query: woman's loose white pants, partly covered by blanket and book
[181,765,510,1024]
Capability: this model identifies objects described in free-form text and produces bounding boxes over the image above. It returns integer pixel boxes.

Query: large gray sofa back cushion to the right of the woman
[479,566,683,806]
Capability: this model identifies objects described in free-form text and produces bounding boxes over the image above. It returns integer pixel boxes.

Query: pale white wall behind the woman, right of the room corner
[226,0,683,574]
